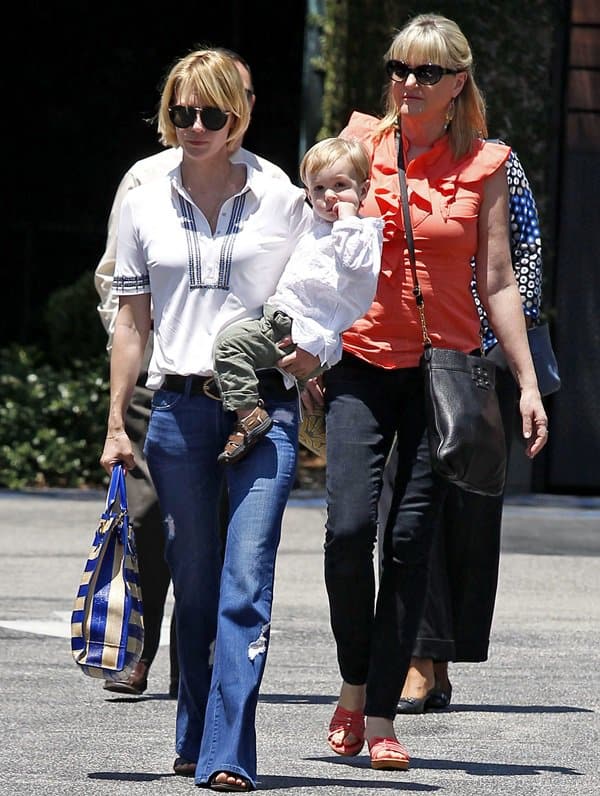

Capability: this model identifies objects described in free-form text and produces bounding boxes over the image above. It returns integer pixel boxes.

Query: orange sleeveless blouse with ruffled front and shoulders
[340,112,510,368]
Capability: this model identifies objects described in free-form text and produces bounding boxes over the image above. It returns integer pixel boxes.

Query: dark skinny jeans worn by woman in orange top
[324,354,445,719]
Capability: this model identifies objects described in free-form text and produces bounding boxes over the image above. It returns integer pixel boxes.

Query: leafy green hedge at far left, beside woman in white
[0,346,109,489]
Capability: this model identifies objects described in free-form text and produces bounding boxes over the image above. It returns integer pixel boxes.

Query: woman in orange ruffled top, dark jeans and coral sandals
[316,14,547,769]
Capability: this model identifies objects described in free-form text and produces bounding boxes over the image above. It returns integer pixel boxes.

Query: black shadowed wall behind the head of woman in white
[8,0,305,345]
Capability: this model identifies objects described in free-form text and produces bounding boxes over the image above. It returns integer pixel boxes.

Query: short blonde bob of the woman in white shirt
[157,49,250,152]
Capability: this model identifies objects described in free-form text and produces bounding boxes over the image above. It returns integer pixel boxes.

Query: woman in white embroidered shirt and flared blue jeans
[101,49,311,791]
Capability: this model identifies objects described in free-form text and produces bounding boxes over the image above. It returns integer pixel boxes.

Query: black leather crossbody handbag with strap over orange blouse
[398,142,506,495]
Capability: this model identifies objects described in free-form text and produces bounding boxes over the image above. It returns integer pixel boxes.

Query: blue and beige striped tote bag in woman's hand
[71,464,144,680]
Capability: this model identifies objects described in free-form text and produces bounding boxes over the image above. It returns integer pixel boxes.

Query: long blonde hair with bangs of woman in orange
[380,14,487,160]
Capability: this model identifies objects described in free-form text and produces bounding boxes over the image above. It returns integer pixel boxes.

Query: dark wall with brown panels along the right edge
[545,0,600,495]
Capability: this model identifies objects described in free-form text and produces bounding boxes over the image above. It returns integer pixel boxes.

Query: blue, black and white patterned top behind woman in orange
[471,151,542,351]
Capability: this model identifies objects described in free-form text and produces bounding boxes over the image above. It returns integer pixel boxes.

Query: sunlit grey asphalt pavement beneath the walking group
[0,491,600,796]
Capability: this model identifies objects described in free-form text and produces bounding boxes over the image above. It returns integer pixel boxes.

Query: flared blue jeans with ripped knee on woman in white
[145,376,298,787]
